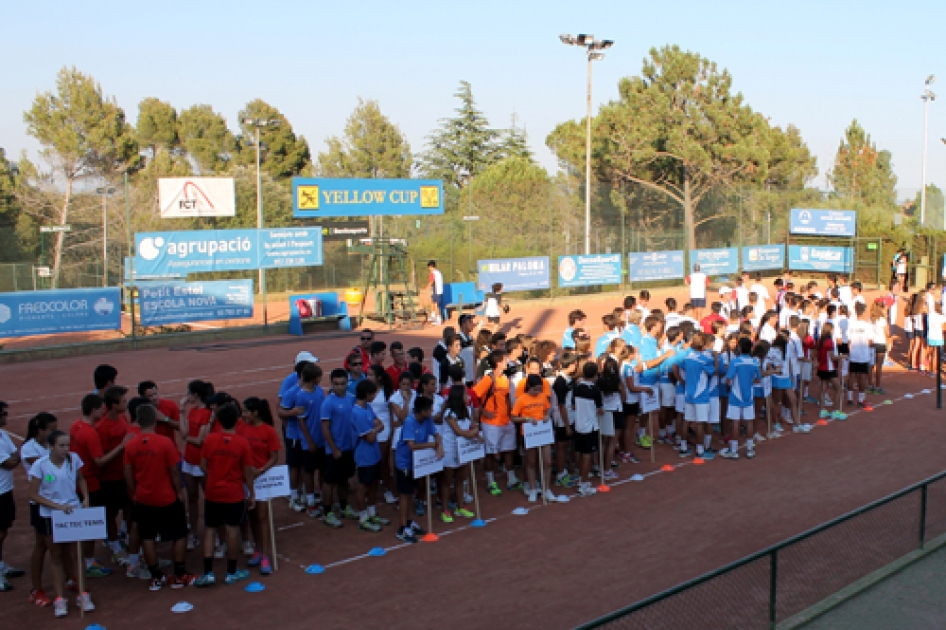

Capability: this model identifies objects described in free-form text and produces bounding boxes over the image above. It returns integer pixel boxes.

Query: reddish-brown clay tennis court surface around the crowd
[0,289,946,630]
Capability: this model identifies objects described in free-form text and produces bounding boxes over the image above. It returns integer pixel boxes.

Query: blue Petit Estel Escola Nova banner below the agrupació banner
[138,280,253,326]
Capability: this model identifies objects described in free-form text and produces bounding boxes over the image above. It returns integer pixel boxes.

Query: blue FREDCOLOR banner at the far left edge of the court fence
[0,287,122,337]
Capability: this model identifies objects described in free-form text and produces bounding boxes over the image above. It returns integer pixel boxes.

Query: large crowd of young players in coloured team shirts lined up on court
[0,268,946,616]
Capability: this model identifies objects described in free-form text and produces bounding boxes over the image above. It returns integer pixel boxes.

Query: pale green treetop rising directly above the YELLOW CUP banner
[316,98,412,179]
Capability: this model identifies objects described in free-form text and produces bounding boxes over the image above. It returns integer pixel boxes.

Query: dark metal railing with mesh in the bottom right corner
[580,472,946,630]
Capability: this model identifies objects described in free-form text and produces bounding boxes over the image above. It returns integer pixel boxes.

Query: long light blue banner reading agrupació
[135,227,322,278]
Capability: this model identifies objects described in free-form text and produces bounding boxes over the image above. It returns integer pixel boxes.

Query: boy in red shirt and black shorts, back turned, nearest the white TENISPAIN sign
[194,404,256,587]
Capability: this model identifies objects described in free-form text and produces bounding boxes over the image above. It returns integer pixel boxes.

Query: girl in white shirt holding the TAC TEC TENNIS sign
[29,431,95,617]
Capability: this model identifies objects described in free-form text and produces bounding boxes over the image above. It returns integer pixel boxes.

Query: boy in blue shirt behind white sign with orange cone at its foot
[394,396,443,543]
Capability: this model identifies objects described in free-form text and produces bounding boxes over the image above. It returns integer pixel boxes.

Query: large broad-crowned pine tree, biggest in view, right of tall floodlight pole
[546,46,770,249]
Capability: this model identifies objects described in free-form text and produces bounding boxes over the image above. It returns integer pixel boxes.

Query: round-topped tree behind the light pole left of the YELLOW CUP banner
[239,99,311,179]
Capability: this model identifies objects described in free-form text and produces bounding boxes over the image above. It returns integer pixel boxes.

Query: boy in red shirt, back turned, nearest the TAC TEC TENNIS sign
[124,404,197,591]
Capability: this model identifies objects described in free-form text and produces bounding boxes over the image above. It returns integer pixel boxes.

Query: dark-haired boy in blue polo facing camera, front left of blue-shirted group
[322,368,358,528]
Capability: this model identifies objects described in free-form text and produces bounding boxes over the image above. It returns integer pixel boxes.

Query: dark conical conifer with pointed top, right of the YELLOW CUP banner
[419,81,502,188]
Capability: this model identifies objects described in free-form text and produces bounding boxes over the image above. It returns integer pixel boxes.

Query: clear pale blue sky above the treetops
[0,0,946,195]
